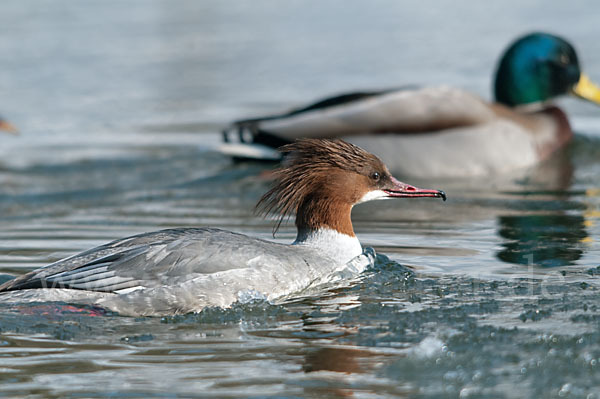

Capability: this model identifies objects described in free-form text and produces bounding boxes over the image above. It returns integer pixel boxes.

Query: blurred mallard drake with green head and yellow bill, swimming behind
[222,33,600,177]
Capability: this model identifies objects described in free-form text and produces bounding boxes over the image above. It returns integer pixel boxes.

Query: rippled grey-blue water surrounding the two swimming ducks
[0,0,600,397]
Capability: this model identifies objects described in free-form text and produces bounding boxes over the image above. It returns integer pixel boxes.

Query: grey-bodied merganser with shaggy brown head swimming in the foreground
[0,139,446,315]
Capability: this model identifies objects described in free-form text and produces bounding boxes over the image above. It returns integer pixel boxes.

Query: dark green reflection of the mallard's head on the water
[498,215,587,267]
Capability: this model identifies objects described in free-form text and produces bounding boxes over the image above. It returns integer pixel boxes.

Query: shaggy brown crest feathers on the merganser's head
[255,139,381,234]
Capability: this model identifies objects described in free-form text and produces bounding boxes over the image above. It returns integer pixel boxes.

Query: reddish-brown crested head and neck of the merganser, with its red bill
[256,139,446,236]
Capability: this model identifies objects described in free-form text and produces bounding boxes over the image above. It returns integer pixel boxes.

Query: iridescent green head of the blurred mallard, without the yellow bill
[494,32,581,106]
